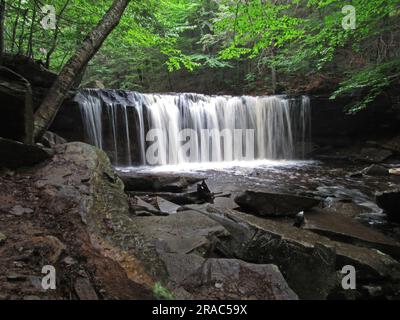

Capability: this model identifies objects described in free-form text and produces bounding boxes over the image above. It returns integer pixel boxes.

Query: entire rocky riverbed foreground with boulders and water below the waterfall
[0,142,400,300]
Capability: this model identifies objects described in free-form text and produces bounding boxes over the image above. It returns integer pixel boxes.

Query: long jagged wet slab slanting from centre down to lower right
[190,205,400,299]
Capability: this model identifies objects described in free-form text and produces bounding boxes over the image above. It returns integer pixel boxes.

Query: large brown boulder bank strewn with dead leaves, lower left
[0,143,153,300]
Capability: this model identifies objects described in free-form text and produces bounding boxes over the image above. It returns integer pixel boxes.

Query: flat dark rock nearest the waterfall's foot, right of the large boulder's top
[118,172,202,192]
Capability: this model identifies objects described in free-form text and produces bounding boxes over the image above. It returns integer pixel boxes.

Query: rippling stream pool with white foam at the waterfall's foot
[117,160,400,238]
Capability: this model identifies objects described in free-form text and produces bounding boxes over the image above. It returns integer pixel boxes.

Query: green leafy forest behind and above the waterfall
[2,0,400,112]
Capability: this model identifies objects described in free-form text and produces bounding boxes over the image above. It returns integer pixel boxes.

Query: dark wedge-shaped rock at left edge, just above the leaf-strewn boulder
[0,138,52,169]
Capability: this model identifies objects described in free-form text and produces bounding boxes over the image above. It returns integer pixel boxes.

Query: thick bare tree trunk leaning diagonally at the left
[34,0,130,140]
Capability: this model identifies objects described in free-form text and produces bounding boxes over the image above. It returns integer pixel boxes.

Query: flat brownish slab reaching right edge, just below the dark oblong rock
[303,208,400,257]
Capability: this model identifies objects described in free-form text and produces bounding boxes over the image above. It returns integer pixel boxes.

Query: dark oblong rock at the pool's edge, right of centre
[235,191,320,216]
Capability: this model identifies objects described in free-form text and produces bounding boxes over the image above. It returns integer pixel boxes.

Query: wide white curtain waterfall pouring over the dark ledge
[75,89,311,166]
